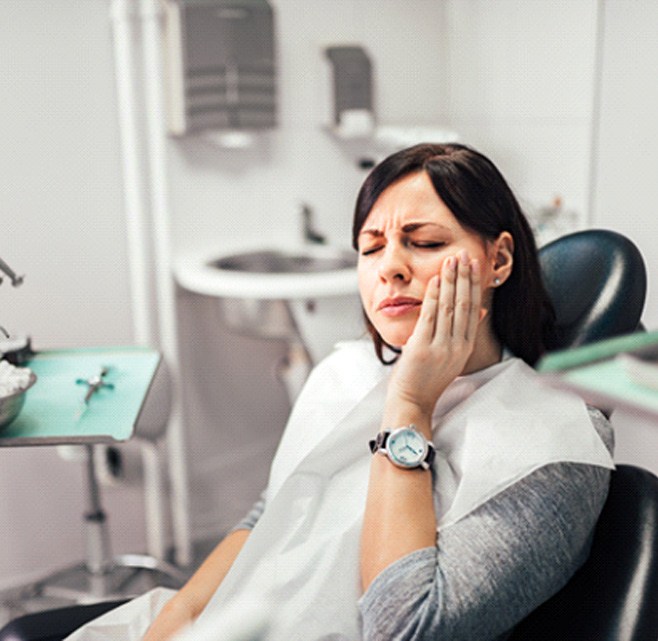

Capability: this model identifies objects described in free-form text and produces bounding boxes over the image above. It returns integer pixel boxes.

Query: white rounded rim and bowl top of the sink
[174,244,357,300]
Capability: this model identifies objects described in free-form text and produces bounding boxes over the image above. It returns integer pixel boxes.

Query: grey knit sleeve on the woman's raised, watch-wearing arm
[359,411,612,641]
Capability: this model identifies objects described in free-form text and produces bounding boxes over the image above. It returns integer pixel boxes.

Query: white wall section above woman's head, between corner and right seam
[444,0,597,226]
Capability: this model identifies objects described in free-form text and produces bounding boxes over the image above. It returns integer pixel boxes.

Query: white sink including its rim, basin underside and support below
[174,242,363,403]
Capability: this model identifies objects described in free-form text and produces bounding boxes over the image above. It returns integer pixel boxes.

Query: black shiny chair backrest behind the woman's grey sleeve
[510,465,658,641]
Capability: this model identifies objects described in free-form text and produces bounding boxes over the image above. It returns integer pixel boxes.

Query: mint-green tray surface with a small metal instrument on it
[0,347,161,447]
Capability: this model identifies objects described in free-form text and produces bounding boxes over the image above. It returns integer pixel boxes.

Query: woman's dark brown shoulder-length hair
[352,143,555,365]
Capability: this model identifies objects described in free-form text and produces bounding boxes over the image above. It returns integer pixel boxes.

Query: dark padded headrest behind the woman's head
[539,229,647,350]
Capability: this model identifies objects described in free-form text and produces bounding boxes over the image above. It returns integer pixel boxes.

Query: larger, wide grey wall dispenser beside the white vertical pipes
[165,0,277,136]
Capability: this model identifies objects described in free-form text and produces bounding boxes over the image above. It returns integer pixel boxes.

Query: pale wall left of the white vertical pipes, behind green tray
[0,0,143,586]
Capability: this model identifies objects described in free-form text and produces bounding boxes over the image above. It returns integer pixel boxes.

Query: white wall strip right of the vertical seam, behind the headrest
[595,0,658,474]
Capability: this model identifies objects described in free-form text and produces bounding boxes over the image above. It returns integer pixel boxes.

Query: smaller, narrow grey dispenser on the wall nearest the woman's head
[325,46,375,138]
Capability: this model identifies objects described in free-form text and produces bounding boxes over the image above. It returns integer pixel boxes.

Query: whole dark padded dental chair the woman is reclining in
[0,230,658,641]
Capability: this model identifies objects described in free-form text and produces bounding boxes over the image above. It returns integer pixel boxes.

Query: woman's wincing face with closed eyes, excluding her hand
[357,171,494,347]
